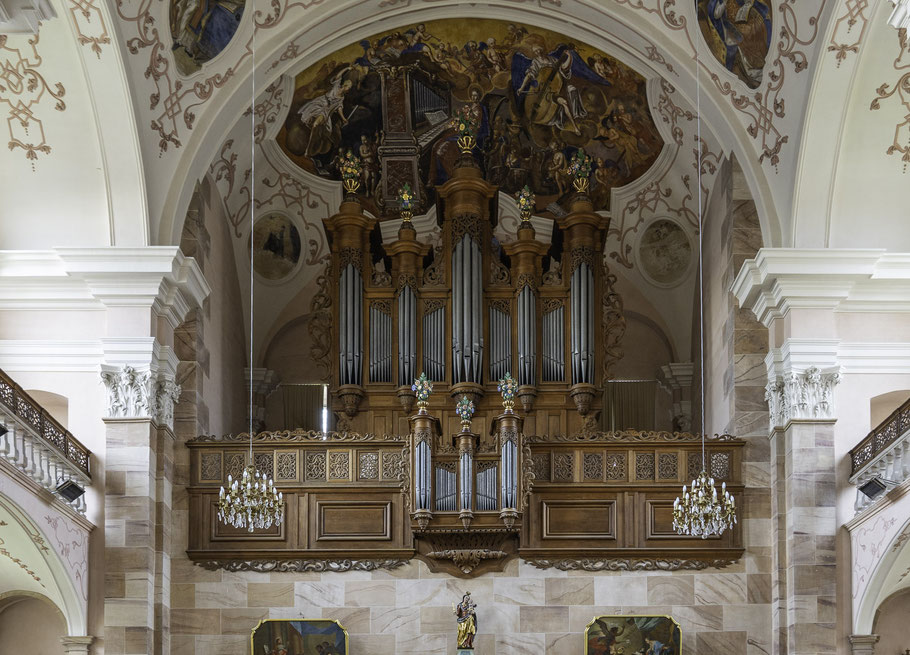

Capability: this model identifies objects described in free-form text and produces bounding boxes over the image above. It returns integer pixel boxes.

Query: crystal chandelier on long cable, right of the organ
[673,34,736,539]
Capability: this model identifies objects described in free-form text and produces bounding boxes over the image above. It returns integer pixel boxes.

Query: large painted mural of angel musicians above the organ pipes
[277,19,663,213]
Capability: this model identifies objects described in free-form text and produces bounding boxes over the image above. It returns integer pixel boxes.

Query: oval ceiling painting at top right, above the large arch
[696,0,772,89]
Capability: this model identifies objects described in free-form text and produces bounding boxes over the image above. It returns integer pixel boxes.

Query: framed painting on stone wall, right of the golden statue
[585,616,682,655]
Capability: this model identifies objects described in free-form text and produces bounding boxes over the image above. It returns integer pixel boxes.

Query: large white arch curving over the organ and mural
[157,0,781,251]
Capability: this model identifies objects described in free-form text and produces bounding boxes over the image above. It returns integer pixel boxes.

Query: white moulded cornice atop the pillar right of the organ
[731,248,910,327]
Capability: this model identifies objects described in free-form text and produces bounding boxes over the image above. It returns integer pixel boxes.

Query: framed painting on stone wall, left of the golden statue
[250,619,348,655]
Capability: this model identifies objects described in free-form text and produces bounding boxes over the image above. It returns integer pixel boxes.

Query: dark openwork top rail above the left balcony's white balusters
[0,370,91,481]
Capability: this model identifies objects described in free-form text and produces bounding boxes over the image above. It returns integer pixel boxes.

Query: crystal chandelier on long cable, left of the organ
[218,10,284,532]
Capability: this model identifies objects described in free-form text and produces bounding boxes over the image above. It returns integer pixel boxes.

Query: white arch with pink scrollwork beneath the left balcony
[0,492,88,635]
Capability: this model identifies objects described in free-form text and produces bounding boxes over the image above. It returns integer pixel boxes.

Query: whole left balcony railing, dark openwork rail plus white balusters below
[0,370,92,512]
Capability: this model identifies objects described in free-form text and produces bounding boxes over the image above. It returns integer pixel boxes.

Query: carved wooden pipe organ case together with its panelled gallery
[188,155,744,576]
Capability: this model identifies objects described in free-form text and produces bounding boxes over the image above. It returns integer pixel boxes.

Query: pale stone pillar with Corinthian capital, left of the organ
[95,249,208,655]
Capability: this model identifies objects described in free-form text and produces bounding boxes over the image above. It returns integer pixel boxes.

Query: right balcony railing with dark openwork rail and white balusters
[850,398,910,512]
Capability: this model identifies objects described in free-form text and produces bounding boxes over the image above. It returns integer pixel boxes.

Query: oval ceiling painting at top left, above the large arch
[170,0,245,75]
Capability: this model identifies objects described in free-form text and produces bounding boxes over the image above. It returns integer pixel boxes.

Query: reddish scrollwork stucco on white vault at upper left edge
[0,34,66,170]
